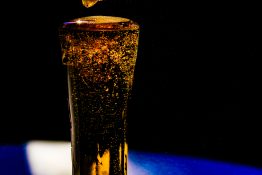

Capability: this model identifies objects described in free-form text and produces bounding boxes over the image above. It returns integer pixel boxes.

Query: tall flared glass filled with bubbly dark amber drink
[59,16,139,175]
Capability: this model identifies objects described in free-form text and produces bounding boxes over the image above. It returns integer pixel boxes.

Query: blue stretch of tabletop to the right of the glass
[129,151,262,175]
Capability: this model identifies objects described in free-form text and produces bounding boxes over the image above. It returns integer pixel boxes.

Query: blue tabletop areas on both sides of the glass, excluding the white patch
[0,145,262,175]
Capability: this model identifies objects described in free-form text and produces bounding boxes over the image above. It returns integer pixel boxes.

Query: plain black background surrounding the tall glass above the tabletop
[0,0,262,167]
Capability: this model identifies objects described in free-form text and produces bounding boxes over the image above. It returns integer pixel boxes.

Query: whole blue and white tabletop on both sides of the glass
[0,141,262,175]
